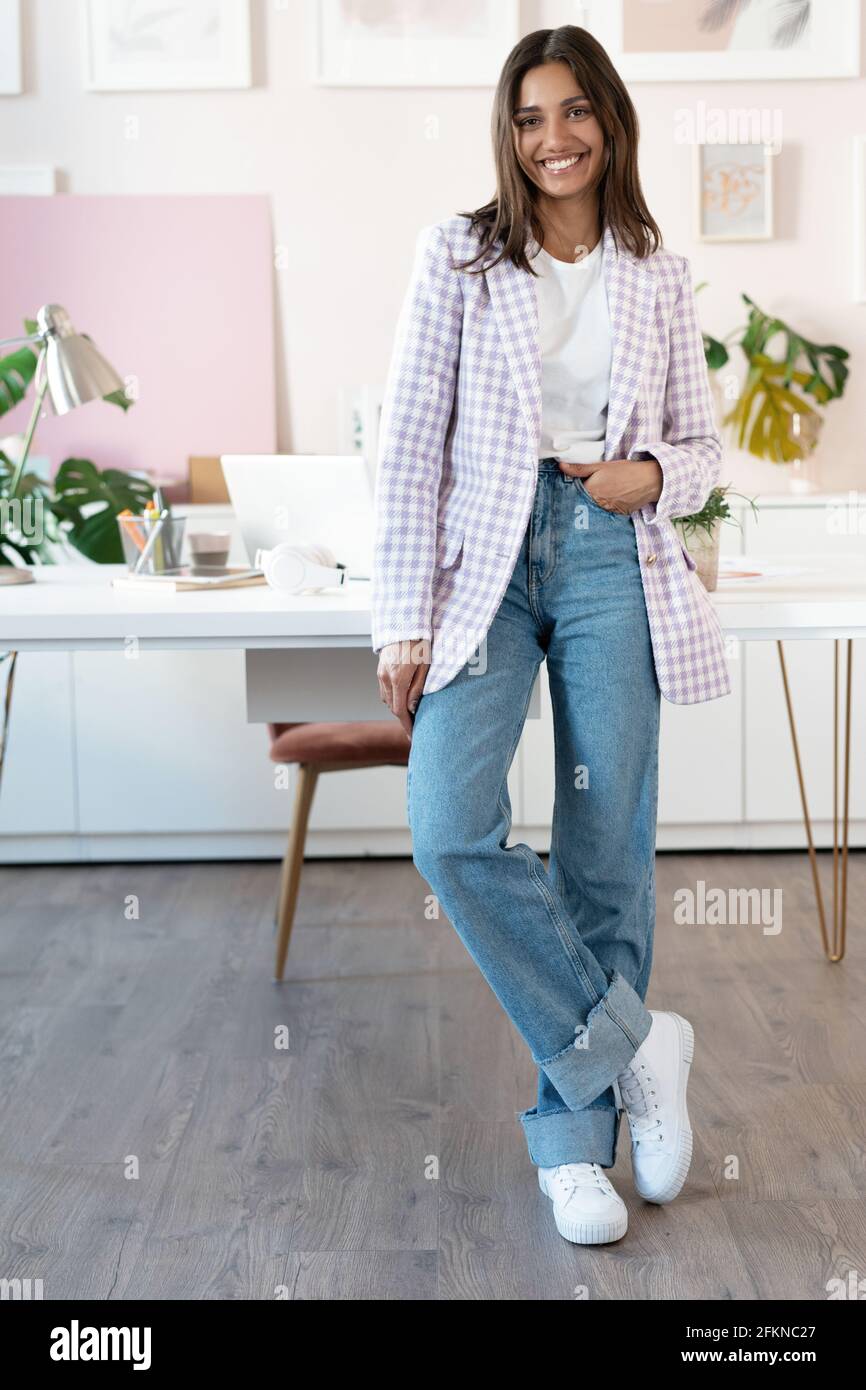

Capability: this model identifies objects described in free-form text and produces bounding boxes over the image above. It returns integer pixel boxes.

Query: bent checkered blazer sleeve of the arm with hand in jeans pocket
[628,257,721,525]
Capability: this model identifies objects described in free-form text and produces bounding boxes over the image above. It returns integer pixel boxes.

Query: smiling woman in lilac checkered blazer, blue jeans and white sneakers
[373,25,731,1244]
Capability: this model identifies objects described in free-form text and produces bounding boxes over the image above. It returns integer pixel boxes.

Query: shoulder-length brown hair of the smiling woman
[456,24,662,275]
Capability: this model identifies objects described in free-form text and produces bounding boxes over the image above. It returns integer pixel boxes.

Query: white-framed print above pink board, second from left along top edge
[82,0,252,92]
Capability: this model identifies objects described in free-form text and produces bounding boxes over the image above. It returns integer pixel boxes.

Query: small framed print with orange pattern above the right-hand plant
[694,143,774,242]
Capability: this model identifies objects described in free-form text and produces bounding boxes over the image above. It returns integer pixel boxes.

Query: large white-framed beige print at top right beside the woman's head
[574,0,860,82]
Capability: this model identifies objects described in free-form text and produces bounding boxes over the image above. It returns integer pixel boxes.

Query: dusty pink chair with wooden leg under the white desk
[268,719,411,980]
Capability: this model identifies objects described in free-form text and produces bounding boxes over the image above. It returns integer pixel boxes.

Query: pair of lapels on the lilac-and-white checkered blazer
[485,227,656,459]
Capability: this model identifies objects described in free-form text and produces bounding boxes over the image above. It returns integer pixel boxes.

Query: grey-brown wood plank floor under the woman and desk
[0,852,866,1300]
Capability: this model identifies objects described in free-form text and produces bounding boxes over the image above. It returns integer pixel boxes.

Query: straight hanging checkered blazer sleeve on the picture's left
[371,225,463,652]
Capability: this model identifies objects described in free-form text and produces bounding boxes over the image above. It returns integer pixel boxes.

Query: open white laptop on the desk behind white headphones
[220,453,374,580]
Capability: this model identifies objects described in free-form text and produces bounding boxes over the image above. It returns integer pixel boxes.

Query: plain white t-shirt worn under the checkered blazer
[530,238,612,463]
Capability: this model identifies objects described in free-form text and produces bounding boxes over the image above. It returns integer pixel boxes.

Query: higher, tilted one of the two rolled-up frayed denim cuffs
[532,970,652,1111]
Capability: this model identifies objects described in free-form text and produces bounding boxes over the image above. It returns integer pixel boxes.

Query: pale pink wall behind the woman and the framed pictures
[0,0,866,491]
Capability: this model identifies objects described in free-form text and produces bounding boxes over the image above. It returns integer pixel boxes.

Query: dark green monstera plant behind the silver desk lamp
[0,320,153,566]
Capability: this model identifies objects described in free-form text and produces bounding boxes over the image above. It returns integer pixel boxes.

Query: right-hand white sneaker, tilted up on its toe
[617,1009,695,1202]
